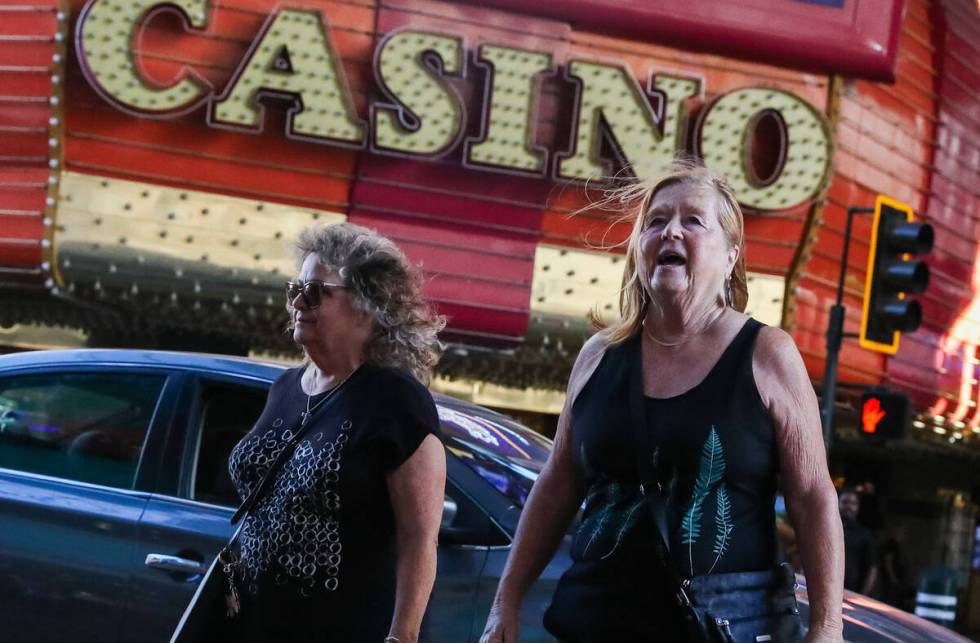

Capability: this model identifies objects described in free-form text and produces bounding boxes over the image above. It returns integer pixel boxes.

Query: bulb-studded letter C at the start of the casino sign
[75,0,210,116]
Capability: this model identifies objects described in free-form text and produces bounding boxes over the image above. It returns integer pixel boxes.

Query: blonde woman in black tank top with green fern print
[482,161,843,643]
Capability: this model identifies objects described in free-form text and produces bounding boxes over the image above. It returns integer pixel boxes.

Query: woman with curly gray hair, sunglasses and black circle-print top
[229,223,446,643]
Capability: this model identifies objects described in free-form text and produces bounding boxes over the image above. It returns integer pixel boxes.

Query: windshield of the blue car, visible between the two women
[439,406,551,507]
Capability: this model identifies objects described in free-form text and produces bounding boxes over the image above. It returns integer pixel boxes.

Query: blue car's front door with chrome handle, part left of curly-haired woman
[121,375,269,643]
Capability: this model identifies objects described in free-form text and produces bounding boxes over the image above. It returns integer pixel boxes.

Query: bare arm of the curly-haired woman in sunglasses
[388,435,446,643]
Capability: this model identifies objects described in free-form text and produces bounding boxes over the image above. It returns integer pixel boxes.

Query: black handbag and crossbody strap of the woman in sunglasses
[170,378,356,643]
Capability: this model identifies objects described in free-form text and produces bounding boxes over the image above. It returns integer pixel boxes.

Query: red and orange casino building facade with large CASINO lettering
[0,0,980,632]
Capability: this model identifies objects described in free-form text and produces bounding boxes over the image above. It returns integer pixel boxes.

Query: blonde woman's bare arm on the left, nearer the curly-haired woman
[480,335,605,643]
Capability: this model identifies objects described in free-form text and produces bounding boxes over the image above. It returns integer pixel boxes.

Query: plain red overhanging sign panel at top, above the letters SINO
[458,0,905,81]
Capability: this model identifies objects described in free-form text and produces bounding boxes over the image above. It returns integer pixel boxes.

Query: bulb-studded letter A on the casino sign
[210,9,365,145]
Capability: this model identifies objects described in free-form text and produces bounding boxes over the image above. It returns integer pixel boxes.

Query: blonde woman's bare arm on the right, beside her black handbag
[752,327,844,641]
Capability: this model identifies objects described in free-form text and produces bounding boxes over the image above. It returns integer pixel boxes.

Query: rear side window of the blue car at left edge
[0,372,166,489]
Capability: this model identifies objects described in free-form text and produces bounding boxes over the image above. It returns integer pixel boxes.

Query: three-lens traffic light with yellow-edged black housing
[859,196,933,354]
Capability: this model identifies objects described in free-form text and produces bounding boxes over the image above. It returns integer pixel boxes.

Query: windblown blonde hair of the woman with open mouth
[593,158,749,345]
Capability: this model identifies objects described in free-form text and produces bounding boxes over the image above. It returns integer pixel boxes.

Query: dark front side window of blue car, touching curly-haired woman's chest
[190,381,268,507]
